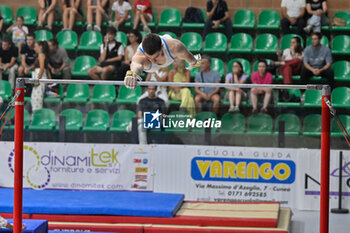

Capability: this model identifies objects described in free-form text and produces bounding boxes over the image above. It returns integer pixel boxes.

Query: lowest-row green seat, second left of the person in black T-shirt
[83,109,109,132]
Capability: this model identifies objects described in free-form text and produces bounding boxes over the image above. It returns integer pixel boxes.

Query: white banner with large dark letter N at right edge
[297,149,350,210]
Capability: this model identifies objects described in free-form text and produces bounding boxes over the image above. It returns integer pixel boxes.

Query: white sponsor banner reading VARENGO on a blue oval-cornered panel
[154,145,298,206]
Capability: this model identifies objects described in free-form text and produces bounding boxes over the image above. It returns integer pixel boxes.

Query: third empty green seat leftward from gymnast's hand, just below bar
[63,84,89,104]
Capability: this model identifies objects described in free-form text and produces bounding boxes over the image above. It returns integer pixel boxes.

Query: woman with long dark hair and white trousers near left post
[31,41,50,112]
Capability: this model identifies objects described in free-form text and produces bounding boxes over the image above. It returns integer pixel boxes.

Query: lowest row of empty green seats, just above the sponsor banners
[7,108,350,137]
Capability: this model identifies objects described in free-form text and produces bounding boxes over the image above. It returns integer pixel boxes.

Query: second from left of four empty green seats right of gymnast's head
[203,32,227,53]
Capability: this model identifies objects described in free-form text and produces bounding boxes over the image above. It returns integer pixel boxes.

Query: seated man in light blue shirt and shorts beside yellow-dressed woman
[194,55,220,114]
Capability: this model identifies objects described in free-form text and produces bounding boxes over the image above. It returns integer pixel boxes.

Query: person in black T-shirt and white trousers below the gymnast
[137,86,167,144]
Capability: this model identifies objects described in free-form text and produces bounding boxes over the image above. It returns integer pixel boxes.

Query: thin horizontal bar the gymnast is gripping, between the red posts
[25,78,323,90]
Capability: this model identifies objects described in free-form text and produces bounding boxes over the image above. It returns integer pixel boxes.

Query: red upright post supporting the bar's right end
[320,86,331,233]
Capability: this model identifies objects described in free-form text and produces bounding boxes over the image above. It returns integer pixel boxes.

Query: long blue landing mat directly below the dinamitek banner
[0,188,184,217]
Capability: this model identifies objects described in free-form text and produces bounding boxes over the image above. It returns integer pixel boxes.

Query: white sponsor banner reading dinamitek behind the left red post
[0,142,153,190]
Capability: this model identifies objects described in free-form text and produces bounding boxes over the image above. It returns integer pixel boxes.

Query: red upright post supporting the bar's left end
[13,79,25,233]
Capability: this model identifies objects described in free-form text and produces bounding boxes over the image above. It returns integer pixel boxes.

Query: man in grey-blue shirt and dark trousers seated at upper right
[300,32,334,88]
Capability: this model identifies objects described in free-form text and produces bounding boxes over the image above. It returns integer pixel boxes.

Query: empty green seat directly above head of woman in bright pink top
[254,33,278,54]
